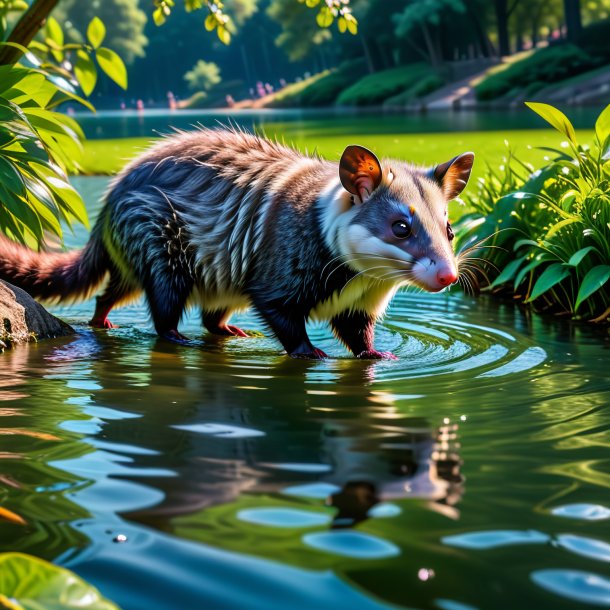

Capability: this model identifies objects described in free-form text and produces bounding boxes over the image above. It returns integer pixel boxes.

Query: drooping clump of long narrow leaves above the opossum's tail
[0,59,87,244]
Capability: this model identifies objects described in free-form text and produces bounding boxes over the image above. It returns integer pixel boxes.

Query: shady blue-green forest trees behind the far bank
[48,0,610,108]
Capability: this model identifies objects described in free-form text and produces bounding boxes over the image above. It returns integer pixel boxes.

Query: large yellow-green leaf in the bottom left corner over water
[0,553,119,610]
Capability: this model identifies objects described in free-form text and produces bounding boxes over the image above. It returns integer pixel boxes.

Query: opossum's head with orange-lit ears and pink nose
[336,146,474,292]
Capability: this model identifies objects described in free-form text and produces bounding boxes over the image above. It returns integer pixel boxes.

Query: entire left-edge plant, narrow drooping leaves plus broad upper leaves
[0,11,127,246]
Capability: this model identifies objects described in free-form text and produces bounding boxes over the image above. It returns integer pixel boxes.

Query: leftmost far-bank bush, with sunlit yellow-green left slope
[268,59,366,108]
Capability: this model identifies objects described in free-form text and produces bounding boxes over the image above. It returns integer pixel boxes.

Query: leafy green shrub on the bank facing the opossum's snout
[456,104,610,321]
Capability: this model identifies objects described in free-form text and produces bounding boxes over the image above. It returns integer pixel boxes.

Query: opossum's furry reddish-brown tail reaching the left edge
[0,233,110,302]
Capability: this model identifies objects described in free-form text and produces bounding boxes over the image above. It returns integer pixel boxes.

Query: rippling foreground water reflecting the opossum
[0,173,610,610]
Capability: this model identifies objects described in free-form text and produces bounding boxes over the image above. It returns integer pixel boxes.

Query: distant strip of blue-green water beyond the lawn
[71,107,602,139]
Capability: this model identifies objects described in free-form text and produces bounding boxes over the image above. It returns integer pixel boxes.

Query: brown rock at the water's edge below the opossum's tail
[0,281,74,351]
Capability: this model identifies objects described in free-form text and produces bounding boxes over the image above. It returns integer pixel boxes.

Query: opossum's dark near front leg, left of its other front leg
[253,299,328,360]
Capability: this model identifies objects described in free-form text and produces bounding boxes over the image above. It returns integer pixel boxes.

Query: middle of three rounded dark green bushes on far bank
[337,63,435,106]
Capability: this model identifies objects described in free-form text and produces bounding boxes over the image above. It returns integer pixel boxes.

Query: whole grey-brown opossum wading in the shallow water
[0,128,474,359]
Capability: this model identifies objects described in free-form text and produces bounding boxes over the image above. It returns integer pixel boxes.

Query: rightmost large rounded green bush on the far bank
[475,44,603,101]
